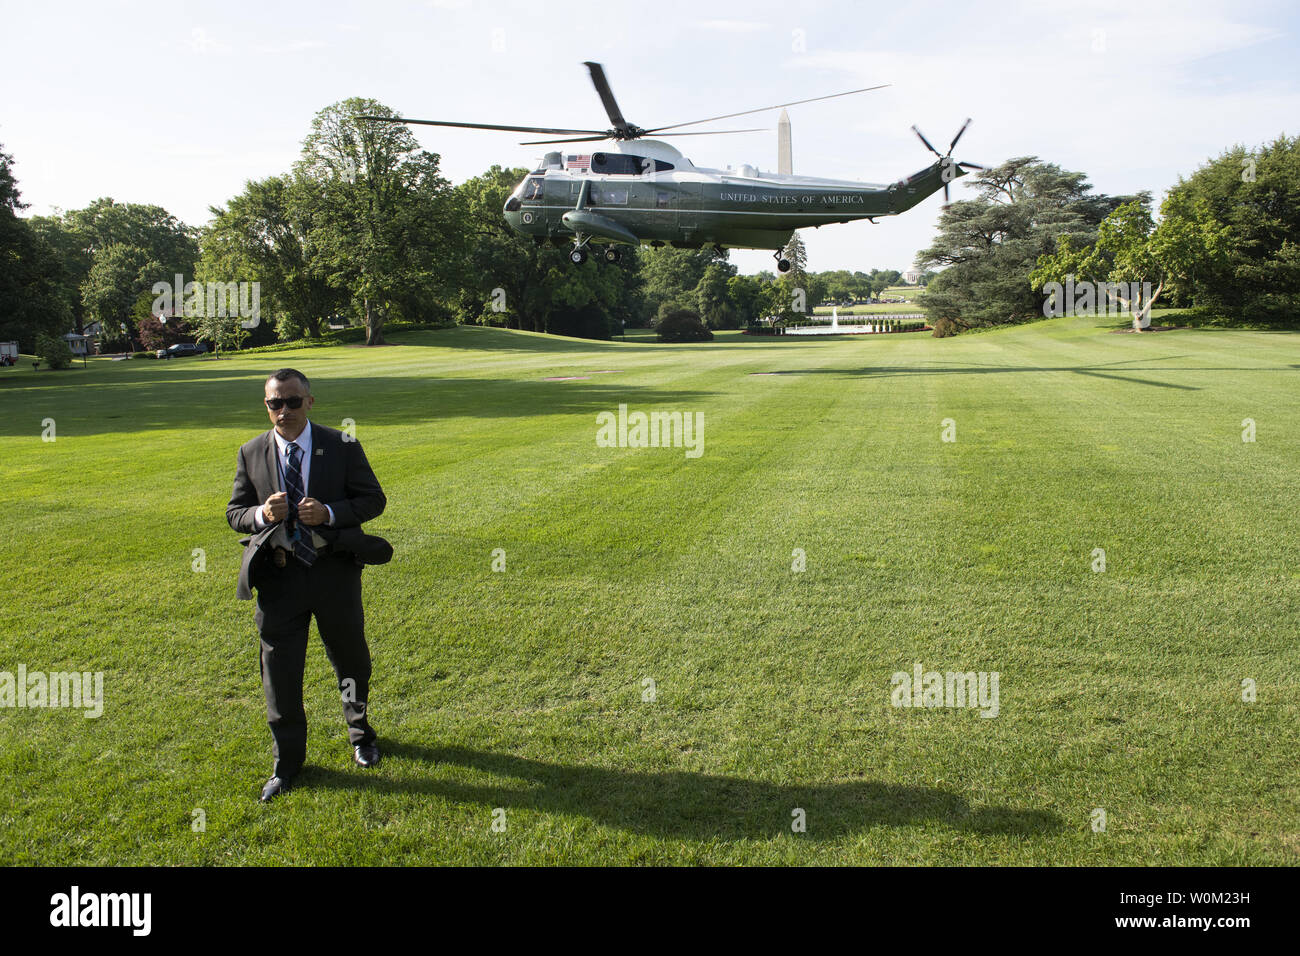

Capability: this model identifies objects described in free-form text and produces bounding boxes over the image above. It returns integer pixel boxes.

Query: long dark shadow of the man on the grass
[302,743,1065,840]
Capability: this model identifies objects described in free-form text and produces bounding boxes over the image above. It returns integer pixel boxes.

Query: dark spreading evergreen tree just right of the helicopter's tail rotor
[917,156,1149,336]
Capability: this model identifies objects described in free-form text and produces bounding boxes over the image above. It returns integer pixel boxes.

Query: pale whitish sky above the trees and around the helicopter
[0,0,1300,272]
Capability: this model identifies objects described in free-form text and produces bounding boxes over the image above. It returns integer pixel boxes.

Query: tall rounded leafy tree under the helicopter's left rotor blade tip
[295,98,465,345]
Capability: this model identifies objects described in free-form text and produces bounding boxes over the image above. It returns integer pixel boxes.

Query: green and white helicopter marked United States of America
[358,61,985,272]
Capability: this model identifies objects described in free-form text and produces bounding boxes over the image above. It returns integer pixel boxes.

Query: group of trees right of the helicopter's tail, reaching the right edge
[917,137,1300,336]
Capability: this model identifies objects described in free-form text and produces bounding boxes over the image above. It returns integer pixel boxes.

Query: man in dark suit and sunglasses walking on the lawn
[226,368,391,803]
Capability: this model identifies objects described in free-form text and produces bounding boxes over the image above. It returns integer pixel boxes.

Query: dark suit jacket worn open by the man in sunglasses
[226,421,393,600]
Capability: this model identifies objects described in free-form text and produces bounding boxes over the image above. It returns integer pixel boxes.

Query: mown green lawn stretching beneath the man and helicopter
[0,319,1300,865]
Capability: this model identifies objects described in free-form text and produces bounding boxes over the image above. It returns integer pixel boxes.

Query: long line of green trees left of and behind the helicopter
[0,99,925,351]
